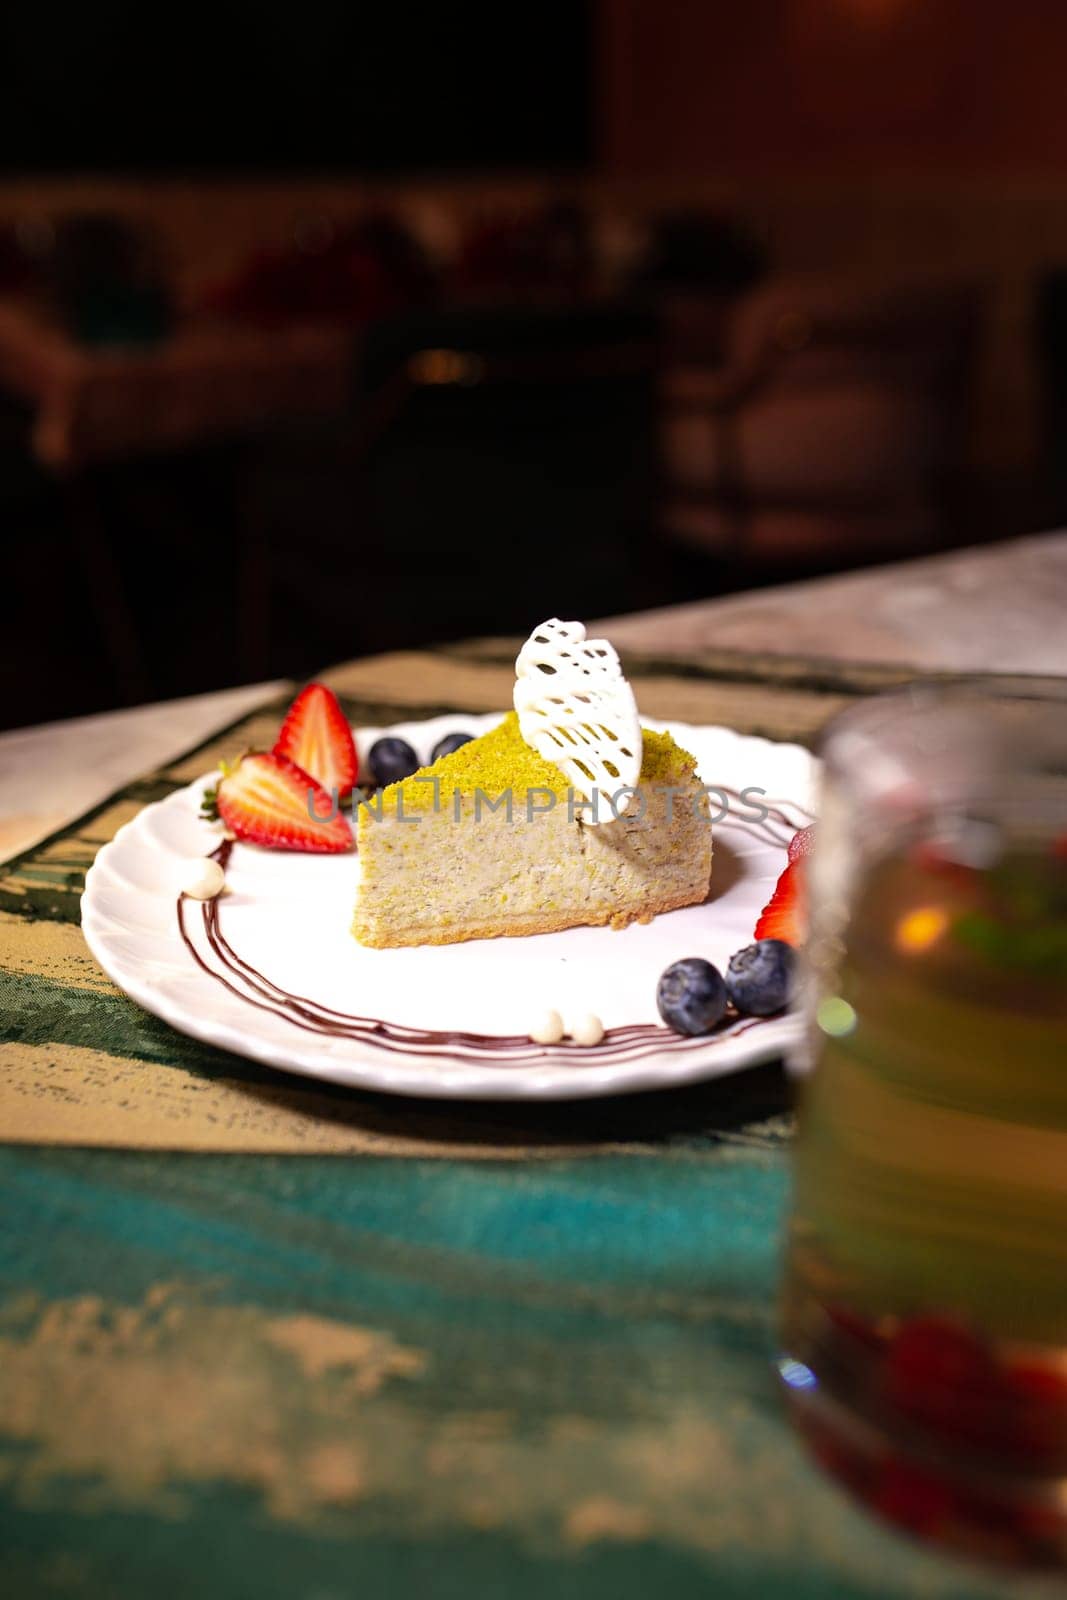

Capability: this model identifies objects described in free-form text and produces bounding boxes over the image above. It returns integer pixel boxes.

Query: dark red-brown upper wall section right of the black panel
[598,0,1067,176]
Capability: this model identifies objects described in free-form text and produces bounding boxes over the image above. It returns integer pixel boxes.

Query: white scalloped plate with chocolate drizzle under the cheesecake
[82,715,817,1099]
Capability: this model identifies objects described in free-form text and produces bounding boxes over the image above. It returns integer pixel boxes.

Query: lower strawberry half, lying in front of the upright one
[205,752,352,853]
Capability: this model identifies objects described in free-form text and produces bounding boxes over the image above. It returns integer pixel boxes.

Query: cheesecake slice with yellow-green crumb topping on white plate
[352,712,712,946]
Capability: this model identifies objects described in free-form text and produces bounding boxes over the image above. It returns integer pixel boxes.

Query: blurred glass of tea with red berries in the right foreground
[779,678,1067,1566]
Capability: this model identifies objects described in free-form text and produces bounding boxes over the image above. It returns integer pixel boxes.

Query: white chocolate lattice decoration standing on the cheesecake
[515,618,641,822]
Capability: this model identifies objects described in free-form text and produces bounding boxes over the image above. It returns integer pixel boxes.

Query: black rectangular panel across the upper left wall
[0,0,589,178]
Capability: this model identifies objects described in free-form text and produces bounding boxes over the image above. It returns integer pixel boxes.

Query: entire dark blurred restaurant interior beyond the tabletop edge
[0,0,1067,726]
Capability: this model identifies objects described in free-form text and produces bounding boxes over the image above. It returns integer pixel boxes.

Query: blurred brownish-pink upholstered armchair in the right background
[659,278,984,581]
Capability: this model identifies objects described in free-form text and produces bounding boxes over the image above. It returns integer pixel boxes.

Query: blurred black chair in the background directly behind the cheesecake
[242,304,659,675]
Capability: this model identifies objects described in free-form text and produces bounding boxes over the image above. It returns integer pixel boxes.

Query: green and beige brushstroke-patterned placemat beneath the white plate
[0,643,1045,1600]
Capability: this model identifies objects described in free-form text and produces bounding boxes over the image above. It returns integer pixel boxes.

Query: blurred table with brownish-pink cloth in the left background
[0,298,355,472]
